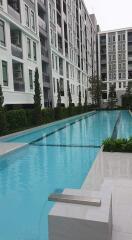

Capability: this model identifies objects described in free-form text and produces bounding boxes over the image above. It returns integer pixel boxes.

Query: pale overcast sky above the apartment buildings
[84,0,132,31]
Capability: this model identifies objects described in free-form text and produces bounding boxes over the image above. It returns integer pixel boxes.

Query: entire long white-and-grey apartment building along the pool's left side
[0,0,97,107]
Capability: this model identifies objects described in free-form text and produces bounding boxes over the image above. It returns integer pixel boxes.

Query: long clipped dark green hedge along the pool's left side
[0,106,93,135]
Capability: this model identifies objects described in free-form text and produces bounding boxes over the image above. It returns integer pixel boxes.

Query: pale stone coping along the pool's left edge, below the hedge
[0,110,97,157]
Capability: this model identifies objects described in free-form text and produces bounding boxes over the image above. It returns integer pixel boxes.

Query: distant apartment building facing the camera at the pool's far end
[98,28,132,105]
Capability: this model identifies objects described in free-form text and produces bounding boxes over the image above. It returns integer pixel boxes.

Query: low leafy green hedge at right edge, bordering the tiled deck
[103,137,132,153]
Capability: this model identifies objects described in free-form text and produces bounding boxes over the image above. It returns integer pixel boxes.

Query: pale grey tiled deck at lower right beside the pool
[83,152,132,240]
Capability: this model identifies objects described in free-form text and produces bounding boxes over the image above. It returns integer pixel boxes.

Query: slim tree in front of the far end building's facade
[108,84,117,109]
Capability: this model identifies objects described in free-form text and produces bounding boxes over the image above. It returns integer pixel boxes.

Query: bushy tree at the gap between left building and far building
[89,76,103,107]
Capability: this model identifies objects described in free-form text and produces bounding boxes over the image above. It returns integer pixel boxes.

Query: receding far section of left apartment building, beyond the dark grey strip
[47,0,97,107]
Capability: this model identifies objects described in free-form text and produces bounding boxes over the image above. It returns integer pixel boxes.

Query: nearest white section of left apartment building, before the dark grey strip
[0,0,44,108]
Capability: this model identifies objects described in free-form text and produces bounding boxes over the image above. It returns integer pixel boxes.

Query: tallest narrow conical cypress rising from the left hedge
[34,68,42,125]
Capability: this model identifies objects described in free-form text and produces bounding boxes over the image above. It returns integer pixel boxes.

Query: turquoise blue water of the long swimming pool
[0,111,132,240]
